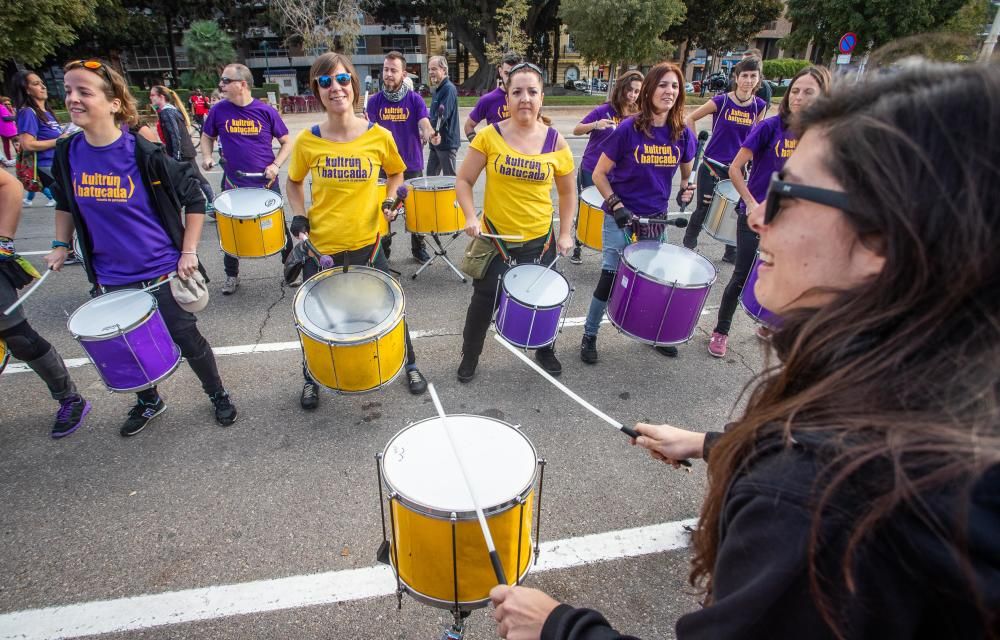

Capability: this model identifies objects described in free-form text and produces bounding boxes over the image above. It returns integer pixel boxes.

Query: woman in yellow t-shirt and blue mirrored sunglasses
[287,53,427,410]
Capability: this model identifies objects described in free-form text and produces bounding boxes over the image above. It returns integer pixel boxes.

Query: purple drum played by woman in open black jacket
[67,289,181,393]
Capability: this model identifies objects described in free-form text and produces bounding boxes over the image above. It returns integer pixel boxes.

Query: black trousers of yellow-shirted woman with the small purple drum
[462,234,556,357]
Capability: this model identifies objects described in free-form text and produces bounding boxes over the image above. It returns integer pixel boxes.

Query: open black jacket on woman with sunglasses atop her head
[52,132,205,284]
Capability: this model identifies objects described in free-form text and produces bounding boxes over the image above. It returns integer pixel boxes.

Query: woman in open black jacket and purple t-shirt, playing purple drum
[45,60,236,437]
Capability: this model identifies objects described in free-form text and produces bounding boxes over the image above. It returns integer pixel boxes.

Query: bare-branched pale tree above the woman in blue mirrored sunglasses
[271,0,361,55]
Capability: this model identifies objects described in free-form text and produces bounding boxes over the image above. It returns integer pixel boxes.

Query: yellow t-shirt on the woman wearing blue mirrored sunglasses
[288,125,406,255]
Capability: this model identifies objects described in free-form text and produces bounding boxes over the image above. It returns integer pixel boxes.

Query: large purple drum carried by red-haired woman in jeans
[608,240,718,346]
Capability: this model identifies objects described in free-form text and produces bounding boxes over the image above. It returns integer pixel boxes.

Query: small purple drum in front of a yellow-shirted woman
[495,264,569,349]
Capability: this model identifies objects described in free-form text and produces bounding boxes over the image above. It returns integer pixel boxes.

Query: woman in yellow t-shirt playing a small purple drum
[455,62,576,382]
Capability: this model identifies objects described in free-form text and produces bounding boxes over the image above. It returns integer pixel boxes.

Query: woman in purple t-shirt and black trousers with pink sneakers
[708,67,830,358]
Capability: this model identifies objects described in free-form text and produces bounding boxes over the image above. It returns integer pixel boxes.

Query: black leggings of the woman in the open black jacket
[103,280,225,404]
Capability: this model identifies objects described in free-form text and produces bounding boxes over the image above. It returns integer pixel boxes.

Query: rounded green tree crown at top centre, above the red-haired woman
[559,0,686,64]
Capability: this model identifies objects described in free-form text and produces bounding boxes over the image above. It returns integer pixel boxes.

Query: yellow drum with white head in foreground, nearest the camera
[379,415,538,610]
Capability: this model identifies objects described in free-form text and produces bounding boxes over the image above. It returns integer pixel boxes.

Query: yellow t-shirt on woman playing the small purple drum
[471,126,573,241]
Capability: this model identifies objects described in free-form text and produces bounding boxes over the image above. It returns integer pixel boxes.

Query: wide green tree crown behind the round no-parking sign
[782,0,966,58]
